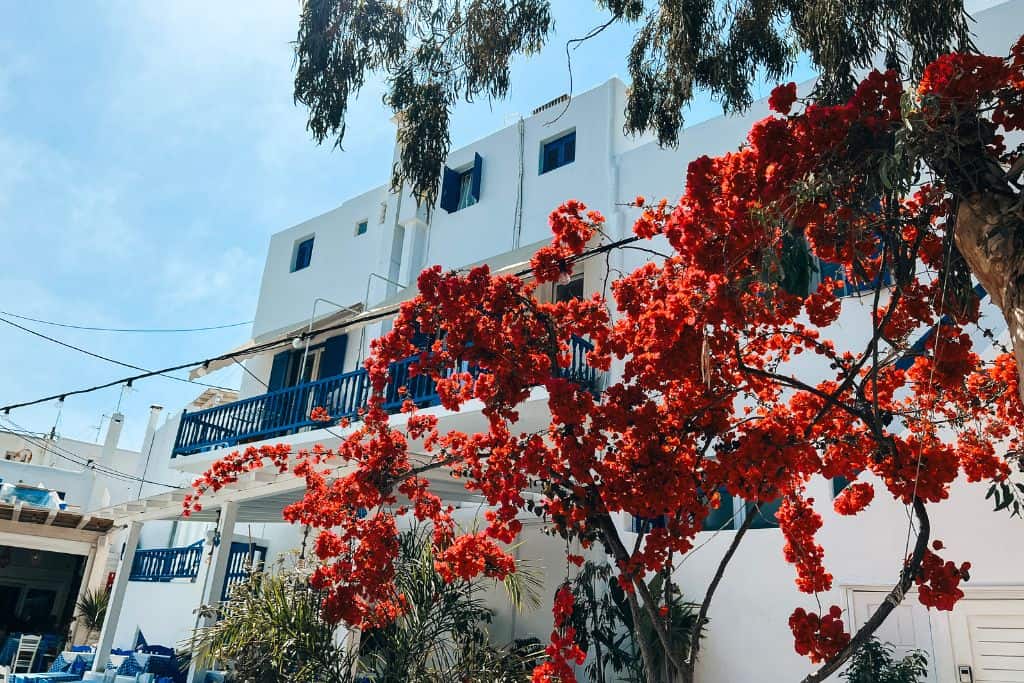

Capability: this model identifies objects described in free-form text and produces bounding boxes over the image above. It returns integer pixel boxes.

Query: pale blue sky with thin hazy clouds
[0,0,798,447]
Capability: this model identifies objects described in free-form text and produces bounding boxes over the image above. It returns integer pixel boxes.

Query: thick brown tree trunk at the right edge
[953,191,1024,399]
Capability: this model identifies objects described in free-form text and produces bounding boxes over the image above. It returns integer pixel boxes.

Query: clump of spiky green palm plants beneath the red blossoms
[188,527,543,683]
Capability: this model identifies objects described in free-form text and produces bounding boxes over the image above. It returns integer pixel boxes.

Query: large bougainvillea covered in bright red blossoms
[185,38,1024,683]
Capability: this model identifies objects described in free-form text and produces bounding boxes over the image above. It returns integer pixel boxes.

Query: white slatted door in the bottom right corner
[949,599,1024,683]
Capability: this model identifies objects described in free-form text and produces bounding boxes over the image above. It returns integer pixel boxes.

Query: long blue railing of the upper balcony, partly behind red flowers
[171,337,598,458]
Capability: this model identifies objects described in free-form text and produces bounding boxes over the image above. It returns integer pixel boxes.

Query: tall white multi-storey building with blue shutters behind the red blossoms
[86,0,1024,683]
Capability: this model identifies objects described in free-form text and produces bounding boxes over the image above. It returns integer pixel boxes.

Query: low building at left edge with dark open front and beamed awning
[0,411,148,664]
